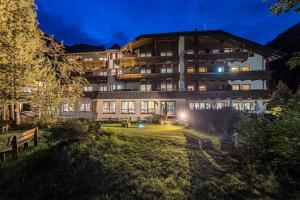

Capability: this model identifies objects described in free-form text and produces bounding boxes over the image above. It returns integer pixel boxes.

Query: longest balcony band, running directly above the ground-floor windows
[85,90,271,100]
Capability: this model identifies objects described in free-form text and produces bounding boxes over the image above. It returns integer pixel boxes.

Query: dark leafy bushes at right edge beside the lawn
[237,83,300,195]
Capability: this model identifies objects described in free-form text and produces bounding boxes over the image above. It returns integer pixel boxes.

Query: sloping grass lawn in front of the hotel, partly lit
[0,124,271,199]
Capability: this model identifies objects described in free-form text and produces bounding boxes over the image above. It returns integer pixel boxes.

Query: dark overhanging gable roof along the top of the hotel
[123,30,284,57]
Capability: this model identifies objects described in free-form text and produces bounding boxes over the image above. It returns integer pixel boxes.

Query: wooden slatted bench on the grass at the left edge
[0,128,38,161]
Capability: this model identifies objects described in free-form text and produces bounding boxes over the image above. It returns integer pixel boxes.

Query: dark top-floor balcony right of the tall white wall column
[185,52,249,61]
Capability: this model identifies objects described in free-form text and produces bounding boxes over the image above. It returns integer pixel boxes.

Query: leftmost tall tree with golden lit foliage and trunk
[0,0,39,124]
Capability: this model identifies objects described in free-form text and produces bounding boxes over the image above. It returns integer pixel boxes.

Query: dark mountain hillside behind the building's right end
[267,23,300,90]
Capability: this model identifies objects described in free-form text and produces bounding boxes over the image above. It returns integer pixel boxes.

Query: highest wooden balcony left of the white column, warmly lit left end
[120,56,179,67]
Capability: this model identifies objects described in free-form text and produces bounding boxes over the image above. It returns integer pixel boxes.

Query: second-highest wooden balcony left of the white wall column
[116,73,179,81]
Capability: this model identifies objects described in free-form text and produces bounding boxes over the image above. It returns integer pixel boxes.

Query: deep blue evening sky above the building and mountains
[36,0,300,46]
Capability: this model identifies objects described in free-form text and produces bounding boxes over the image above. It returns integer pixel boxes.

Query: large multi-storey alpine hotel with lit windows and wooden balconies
[60,30,280,120]
